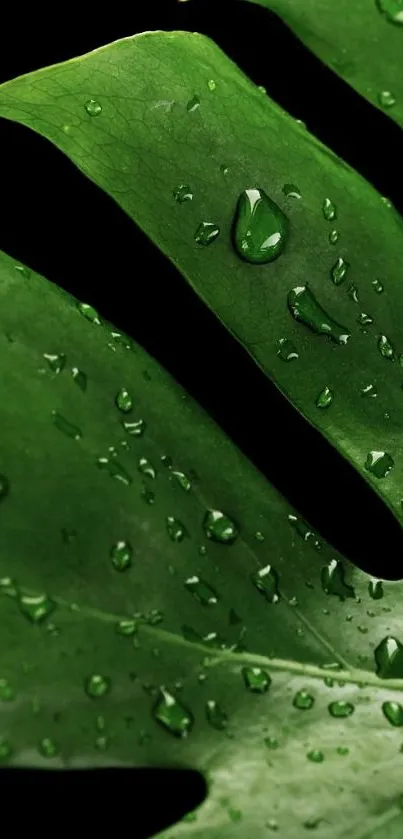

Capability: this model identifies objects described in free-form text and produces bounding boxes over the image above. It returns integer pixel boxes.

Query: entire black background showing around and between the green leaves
[0,0,403,839]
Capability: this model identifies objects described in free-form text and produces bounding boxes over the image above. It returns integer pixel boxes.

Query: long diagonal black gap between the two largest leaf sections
[0,120,403,579]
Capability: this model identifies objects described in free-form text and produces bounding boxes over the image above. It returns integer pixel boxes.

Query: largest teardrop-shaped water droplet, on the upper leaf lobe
[233,188,288,264]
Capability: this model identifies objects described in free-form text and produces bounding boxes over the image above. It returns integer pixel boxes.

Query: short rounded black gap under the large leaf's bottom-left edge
[0,768,207,839]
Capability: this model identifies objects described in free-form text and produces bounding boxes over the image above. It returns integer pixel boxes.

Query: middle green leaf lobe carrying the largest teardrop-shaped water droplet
[0,32,403,522]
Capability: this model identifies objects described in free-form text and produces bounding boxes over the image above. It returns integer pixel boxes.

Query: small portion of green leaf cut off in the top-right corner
[240,0,403,130]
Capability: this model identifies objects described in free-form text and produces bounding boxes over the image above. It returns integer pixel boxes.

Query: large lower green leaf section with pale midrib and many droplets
[0,249,403,839]
